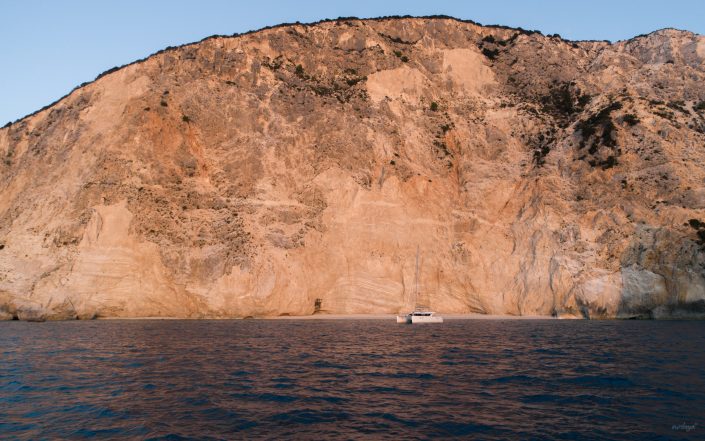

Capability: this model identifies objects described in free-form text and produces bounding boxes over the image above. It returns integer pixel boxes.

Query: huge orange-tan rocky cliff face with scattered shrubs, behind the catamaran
[0,18,705,318]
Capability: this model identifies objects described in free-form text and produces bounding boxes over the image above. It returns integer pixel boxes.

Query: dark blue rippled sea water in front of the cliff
[0,320,705,440]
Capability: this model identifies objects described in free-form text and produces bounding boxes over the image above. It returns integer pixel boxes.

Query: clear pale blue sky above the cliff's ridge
[0,0,705,126]
